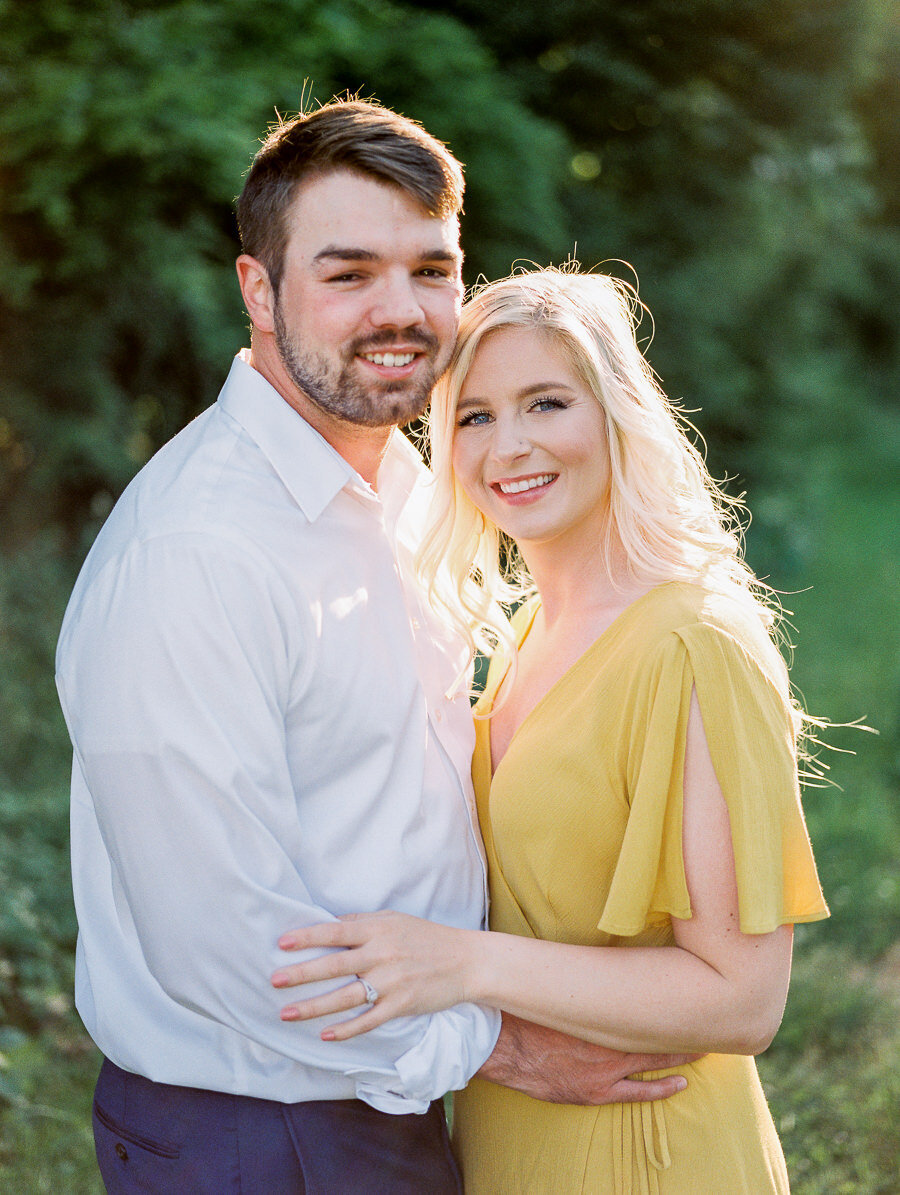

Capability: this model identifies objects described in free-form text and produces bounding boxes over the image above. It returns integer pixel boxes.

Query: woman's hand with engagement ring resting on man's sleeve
[271,911,479,1041]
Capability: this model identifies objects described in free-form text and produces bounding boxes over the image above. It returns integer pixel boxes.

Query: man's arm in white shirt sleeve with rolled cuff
[59,533,498,1113]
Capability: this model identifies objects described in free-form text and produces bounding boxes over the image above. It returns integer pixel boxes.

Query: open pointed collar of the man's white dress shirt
[219,350,424,522]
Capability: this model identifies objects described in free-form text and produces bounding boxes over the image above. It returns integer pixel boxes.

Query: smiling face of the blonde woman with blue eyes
[453,327,610,547]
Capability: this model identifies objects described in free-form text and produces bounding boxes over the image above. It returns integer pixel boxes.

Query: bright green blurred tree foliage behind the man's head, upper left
[0,0,564,547]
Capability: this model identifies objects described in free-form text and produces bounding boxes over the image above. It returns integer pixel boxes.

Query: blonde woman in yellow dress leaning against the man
[272,270,827,1195]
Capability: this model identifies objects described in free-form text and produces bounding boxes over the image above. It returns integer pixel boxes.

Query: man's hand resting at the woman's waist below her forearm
[478,1012,702,1104]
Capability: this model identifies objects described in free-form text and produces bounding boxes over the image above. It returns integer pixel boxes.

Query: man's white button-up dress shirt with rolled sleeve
[57,357,500,1113]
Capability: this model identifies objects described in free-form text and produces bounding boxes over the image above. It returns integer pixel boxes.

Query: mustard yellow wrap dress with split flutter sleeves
[454,582,828,1195]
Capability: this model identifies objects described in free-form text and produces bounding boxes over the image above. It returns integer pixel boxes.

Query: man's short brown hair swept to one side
[237,99,465,293]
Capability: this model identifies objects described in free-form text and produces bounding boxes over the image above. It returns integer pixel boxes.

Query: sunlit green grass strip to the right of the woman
[760,411,900,1195]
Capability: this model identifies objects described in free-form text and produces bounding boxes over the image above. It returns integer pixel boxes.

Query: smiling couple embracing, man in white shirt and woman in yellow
[57,95,827,1195]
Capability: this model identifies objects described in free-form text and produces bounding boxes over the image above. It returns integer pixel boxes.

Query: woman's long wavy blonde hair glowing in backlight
[417,268,775,688]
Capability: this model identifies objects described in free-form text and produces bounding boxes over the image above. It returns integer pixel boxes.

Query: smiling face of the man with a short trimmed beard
[274,170,463,428]
